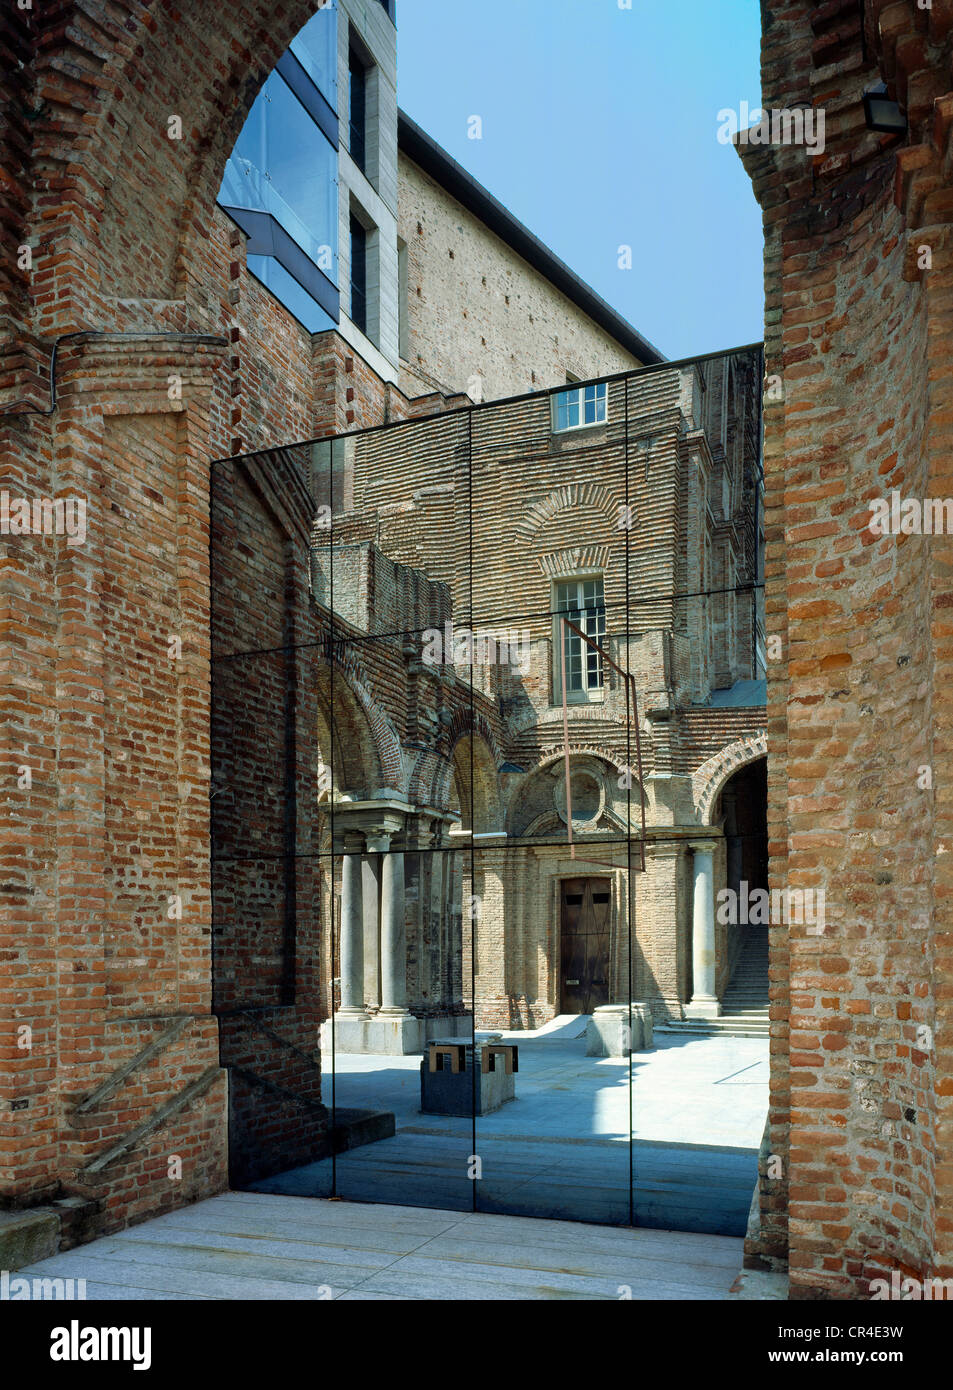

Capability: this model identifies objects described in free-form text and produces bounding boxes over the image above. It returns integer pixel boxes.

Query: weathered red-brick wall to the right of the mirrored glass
[746,0,953,1297]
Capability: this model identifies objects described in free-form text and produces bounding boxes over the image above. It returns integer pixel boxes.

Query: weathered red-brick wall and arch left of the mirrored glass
[0,3,347,1234]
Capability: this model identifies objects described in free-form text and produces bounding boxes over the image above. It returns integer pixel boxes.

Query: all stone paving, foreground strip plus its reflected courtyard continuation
[13,1020,766,1301]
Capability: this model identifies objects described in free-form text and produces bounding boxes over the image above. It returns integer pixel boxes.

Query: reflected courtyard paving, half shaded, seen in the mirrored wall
[254,1019,768,1236]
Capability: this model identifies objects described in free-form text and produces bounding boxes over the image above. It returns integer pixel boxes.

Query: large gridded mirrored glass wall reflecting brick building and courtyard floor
[213,353,767,1234]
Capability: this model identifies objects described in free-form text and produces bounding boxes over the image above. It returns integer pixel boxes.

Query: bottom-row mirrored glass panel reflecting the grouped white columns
[324,828,474,1211]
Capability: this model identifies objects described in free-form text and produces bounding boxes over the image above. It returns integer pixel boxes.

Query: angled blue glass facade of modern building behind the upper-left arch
[218,3,339,332]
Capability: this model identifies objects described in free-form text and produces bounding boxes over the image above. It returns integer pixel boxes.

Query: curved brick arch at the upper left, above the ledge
[0,0,327,338]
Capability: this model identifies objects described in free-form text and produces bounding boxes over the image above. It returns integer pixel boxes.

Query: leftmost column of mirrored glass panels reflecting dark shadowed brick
[210,456,332,1195]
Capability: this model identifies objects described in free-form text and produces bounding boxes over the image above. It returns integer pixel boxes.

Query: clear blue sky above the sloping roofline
[397,0,763,357]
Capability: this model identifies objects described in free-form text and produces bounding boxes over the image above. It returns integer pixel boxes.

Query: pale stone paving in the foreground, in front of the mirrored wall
[18,1193,742,1301]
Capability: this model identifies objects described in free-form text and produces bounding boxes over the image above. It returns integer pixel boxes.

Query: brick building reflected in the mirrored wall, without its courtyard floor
[213,344,765,1176]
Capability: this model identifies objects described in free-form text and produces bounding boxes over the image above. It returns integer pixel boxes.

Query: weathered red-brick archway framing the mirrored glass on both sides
[0,0,953,1298]
